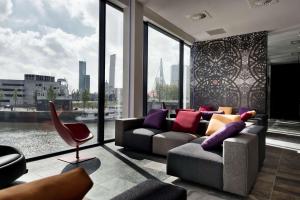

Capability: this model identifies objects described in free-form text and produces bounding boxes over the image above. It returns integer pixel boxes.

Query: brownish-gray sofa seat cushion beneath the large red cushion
[152,131,197,156]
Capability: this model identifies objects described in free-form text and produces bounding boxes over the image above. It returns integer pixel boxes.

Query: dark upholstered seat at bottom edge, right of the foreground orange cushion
[112,179,187,200]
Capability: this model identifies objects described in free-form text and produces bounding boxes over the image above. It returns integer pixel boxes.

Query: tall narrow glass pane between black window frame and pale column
[104,5,123,140]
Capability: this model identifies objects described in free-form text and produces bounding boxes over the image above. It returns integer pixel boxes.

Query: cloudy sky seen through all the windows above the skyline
[0,0,188,92]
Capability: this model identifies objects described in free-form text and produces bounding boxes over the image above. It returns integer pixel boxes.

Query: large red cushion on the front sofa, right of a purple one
[172,111,201,133]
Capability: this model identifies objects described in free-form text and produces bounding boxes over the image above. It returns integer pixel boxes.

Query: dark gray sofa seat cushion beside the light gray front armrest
[167,143,223,190]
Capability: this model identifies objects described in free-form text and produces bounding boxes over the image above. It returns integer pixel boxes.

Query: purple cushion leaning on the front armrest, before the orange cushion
[201,121,246,150]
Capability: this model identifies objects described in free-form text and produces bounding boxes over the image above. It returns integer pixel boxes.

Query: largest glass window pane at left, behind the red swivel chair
[0,0,99,158]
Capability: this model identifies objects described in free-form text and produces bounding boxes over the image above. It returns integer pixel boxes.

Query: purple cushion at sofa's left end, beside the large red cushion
[143,109,169,129]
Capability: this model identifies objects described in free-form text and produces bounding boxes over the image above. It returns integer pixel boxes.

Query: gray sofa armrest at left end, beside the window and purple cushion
[115,118,144,146]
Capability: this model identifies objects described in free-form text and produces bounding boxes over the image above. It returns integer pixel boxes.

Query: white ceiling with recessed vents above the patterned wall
[140,0,300,63]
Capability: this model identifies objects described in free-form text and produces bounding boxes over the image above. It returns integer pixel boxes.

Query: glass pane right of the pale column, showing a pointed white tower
[147,27,179,114]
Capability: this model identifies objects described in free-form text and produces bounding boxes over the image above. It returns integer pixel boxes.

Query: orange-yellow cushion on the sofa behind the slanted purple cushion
[205,114,241,136]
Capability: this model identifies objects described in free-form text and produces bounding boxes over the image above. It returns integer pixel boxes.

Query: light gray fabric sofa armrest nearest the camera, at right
[223,133,258,196]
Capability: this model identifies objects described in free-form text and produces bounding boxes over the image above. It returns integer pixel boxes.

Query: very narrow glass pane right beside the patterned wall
[183,45,191,108]
